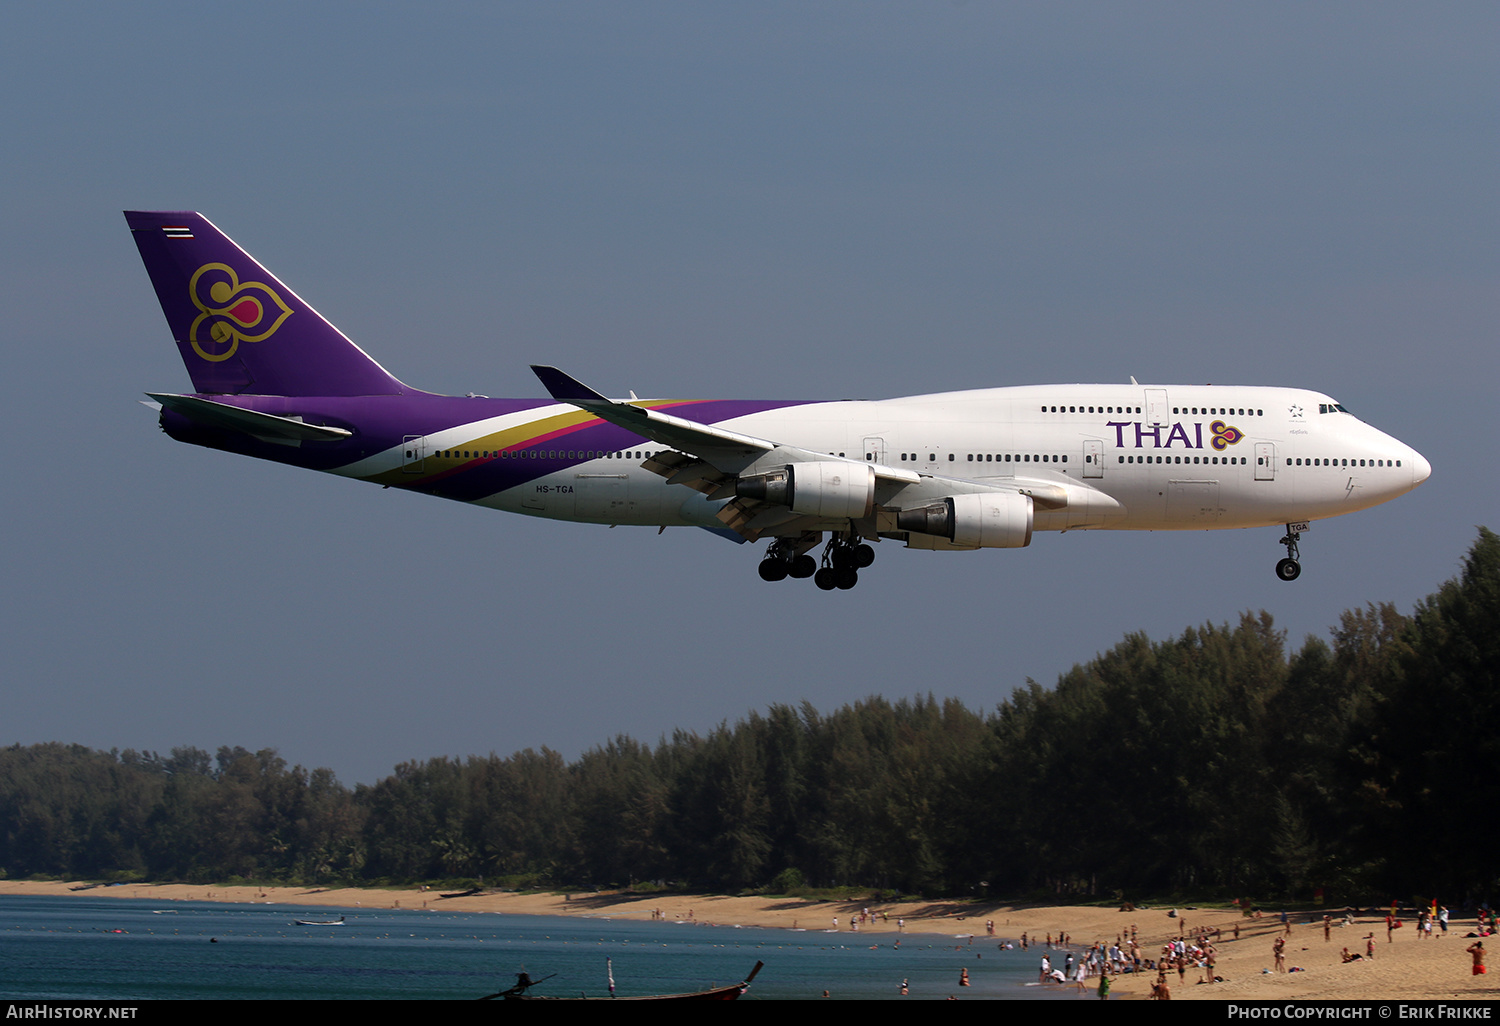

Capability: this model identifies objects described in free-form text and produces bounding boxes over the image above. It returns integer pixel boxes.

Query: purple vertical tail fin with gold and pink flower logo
[125,210,410,396]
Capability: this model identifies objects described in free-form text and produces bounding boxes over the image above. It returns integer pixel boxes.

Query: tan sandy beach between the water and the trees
[0,881,1500,1001]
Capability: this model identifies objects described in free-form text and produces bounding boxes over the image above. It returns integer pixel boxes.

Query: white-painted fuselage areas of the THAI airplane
[479,384,1431,531]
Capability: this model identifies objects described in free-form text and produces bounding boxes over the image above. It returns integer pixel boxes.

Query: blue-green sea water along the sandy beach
[0,896,1094,1001]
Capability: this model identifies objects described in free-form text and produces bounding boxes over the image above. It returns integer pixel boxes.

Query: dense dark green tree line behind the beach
[0,530,1500,903]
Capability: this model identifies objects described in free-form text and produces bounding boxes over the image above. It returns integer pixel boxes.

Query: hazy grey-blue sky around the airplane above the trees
[0,2,1500,783]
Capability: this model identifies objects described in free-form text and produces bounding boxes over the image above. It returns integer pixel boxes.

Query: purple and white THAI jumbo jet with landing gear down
[125,210,1433,591]
